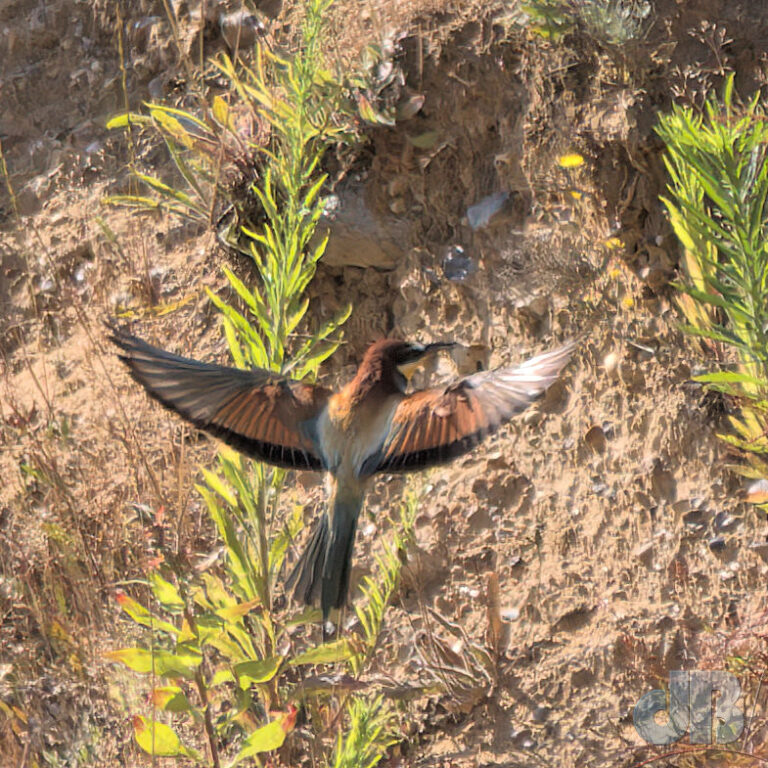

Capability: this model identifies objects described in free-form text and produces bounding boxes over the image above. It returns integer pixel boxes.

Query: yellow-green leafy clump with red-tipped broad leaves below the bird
[107,484,416,766]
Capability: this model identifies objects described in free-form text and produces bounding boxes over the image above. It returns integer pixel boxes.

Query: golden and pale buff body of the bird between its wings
[318,392,402,477]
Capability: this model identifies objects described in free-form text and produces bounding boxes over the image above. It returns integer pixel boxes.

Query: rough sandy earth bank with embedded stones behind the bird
[0,0,768,767]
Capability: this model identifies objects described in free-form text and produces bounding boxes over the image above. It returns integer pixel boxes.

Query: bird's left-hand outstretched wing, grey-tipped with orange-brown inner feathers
[110,328,331,469]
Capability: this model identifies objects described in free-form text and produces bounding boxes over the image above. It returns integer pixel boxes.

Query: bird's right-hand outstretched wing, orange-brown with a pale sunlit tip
[363,342,576,474]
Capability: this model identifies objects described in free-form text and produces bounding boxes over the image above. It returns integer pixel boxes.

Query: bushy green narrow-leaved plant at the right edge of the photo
[657,75,768,488]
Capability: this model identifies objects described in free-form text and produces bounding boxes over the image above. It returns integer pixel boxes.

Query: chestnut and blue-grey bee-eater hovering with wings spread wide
[110,328,575,622]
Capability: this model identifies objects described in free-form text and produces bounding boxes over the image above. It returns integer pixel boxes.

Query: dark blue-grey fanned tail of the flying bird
[286,494,362,621]
